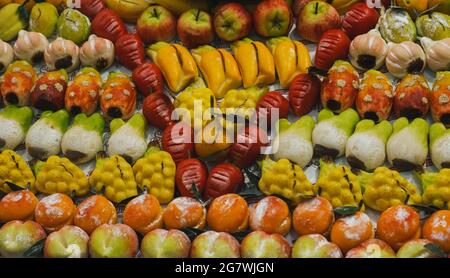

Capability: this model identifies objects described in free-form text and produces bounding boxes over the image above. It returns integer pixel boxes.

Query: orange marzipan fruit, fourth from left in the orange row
[123,194,163,235]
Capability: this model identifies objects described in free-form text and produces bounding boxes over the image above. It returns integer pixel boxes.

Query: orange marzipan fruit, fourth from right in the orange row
[293,197,334,236]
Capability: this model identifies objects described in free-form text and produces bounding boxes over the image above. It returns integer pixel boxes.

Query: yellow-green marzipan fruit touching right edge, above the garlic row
[416,12,450,41]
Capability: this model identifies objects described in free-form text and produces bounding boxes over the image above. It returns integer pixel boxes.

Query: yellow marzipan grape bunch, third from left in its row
[89,153,138,203]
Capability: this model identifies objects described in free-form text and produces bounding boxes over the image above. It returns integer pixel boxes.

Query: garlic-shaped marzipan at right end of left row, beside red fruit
[80,35,114,71]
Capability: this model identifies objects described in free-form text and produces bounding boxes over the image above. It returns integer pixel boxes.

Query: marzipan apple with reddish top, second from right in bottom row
[345,239,395,258]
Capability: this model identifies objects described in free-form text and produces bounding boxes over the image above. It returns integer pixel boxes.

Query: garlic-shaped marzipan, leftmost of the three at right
[350,29,388,71]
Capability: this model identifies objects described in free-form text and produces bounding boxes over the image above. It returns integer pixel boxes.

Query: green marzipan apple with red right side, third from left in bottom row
[89,224,139,258]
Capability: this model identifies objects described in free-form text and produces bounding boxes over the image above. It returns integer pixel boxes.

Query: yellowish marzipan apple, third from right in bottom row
[292,234,342,258]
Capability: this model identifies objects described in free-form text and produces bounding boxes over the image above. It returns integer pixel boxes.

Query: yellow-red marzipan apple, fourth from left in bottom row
[141,229,191,258]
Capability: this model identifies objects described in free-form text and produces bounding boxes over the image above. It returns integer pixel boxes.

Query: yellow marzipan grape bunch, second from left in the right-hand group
[314,160,364,210]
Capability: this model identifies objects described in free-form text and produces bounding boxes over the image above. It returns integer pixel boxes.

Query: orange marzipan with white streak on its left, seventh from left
[249,196,291,235]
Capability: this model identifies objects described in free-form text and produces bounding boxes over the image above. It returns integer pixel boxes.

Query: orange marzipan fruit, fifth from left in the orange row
[163,197,206,229]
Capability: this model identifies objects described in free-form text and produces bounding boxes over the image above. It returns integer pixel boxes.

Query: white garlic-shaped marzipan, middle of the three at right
[386,41,426,78]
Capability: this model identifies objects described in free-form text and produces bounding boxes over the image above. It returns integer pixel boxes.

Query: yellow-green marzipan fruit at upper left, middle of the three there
[30,3,58,37]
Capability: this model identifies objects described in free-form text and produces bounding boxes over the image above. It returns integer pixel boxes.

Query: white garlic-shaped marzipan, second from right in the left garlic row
[44,38,80,72]
